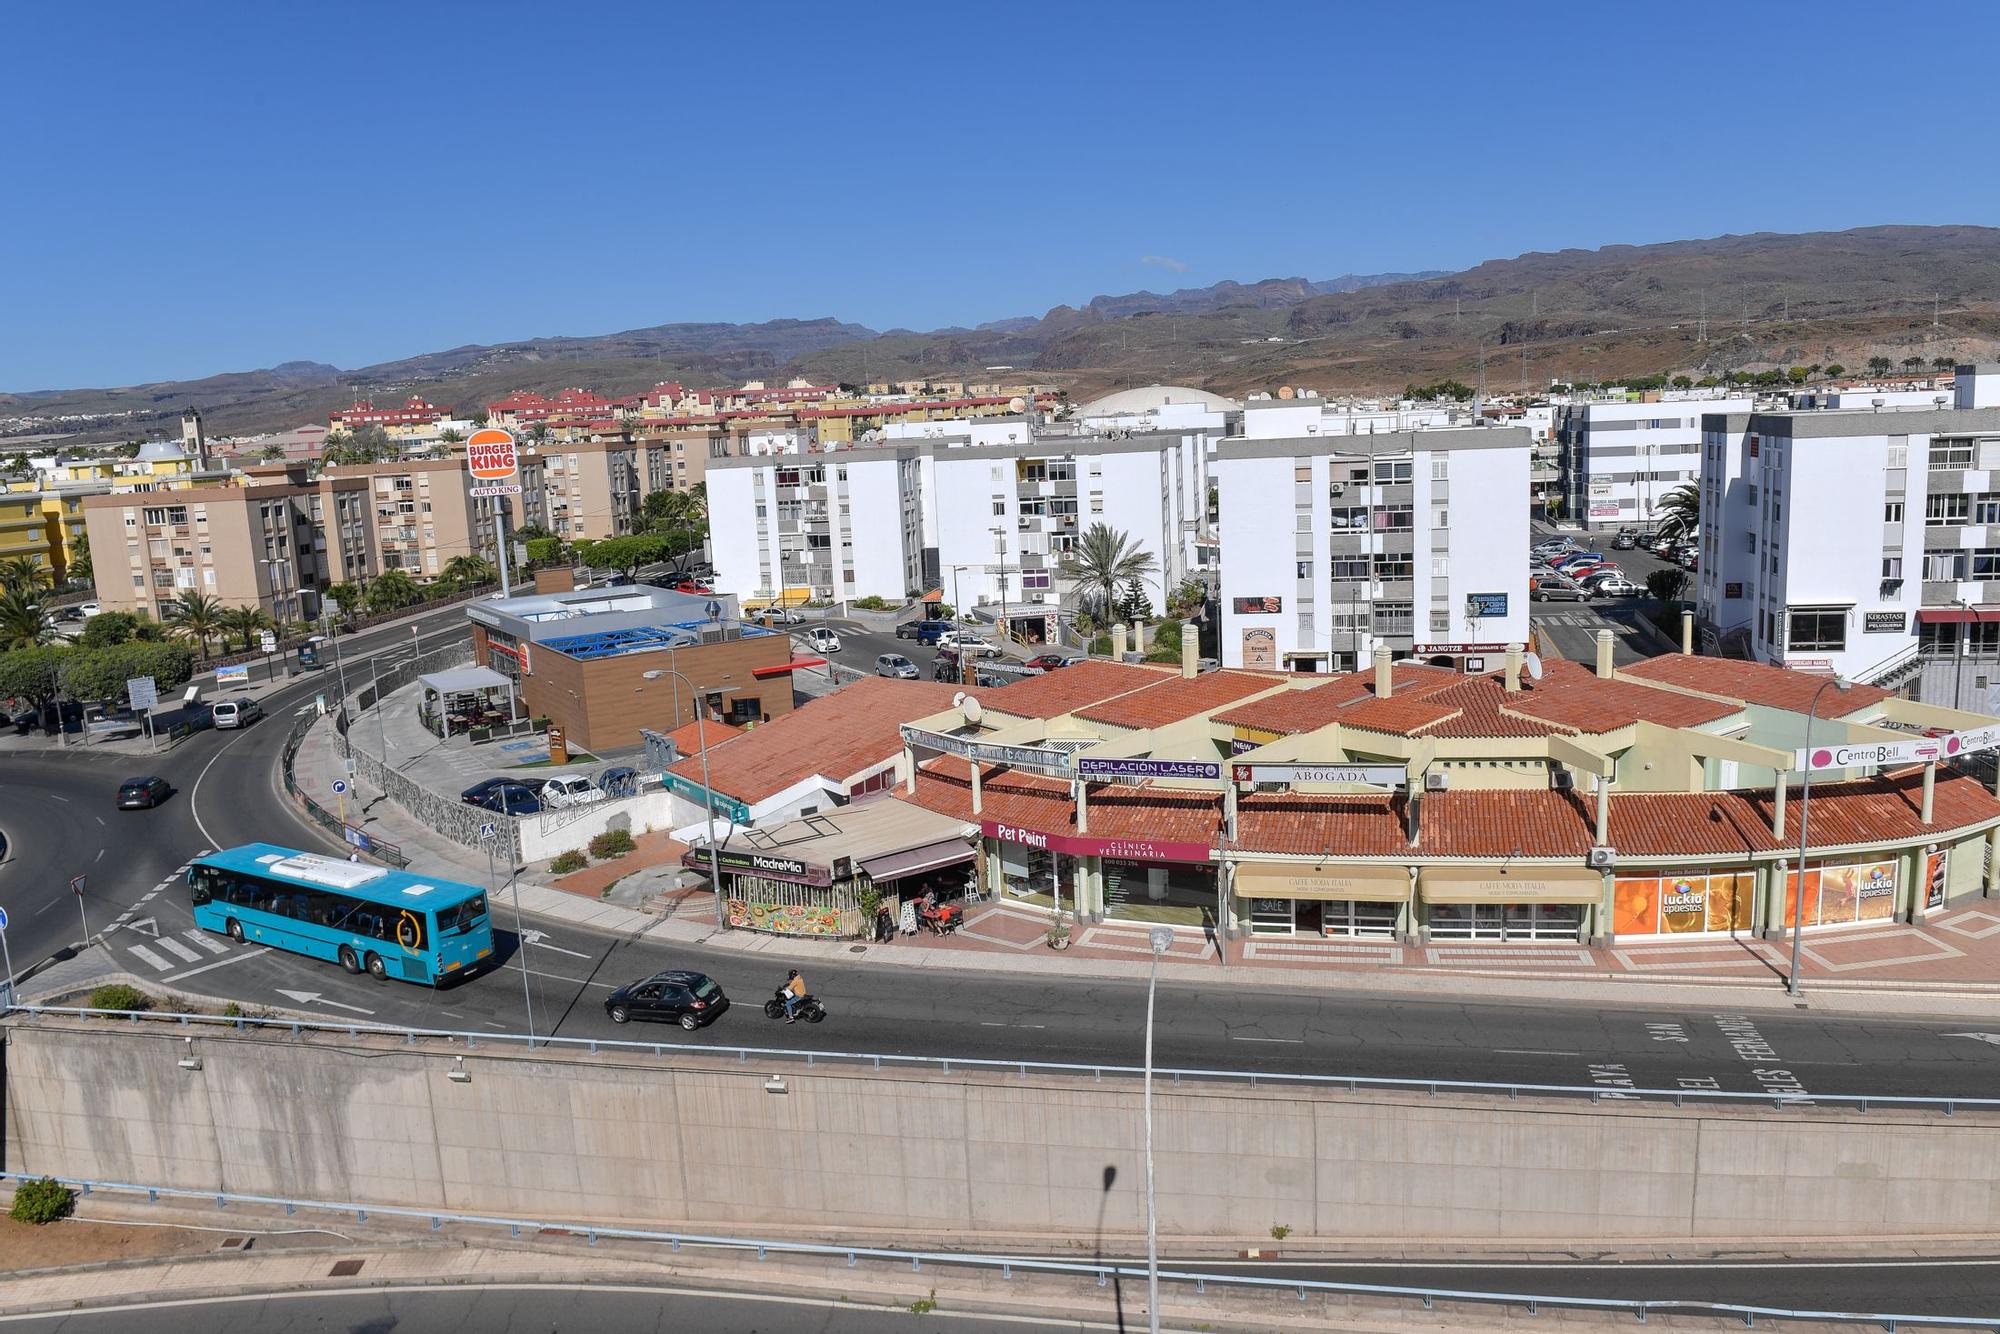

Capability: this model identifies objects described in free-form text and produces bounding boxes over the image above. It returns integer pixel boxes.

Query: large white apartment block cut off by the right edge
[1696,366,2000,708]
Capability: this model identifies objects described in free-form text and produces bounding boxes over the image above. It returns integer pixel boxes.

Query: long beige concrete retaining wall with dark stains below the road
[4,1020,2000,1246]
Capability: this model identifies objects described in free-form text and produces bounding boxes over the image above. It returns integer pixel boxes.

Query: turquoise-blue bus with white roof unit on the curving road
[188,844,494,986]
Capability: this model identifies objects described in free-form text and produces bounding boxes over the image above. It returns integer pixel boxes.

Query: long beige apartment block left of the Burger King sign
[84,456,548,620]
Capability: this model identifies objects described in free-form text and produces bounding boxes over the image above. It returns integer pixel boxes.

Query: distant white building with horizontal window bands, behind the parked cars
[1554,390,1756,530]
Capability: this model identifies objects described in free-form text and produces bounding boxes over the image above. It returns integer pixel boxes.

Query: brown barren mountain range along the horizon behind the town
[0,226,2000,440]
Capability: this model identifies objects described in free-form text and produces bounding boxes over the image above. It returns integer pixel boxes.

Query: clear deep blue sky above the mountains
[0,0,2000,390]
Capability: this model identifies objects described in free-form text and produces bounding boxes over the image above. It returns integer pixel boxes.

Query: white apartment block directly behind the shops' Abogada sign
[1214,428,1530,672]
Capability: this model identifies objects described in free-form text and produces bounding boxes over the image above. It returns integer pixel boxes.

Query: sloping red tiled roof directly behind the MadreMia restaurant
[668,676,956,804]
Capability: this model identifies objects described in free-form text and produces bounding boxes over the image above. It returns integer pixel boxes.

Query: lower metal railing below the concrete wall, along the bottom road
[0,1172,2000,1334]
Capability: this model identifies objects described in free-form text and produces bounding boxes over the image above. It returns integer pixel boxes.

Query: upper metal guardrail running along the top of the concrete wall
[0,1006,2000,1116]
